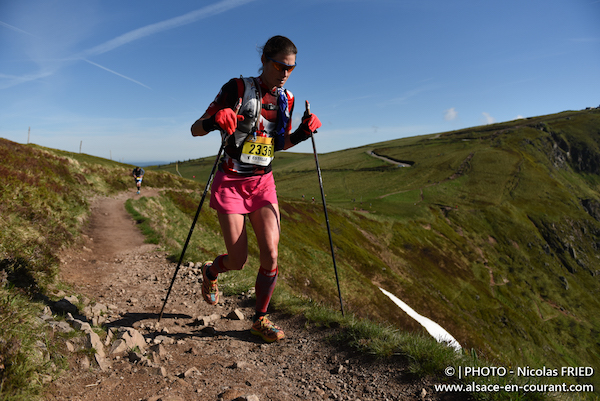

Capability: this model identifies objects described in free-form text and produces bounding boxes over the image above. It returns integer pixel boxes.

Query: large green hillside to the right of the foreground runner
[154,109,600,386]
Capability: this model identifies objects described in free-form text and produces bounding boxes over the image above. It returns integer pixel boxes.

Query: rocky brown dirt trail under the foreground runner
[41,189,466,401]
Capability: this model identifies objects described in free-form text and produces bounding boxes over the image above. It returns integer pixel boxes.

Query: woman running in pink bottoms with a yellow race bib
[191,36,321,342]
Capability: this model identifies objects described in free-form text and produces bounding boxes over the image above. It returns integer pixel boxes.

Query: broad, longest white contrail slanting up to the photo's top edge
[83,0,254,57]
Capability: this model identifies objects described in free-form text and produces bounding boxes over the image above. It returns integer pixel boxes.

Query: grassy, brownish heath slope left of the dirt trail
[0,138,197,401]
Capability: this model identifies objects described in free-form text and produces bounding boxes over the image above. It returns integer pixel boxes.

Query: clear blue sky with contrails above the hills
[0,0,600,164]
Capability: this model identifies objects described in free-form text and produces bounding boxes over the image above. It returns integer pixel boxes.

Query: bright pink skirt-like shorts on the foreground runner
[210,171,277,214]
